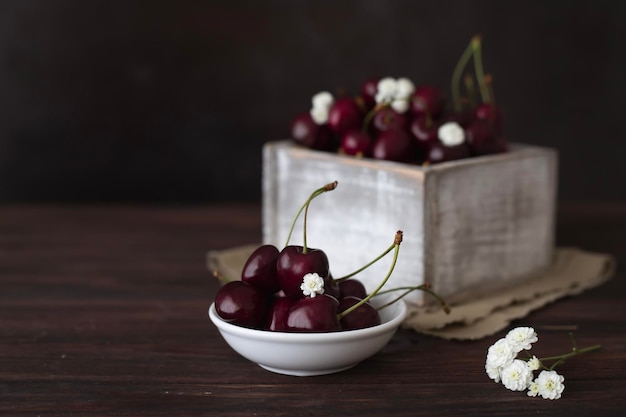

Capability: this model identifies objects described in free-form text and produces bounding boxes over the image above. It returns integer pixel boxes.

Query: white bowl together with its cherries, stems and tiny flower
[209,182,447,376]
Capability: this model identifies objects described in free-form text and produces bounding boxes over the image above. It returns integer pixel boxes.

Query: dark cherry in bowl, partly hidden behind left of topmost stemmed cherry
[241,245,280,294]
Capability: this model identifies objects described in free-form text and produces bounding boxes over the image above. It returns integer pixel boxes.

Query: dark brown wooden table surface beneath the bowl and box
[0,205,626,417]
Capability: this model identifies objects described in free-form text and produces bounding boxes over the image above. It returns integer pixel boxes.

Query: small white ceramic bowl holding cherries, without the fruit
[209,295,406,376]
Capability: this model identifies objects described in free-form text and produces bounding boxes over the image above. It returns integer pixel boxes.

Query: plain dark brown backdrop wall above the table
[0,0,626,203]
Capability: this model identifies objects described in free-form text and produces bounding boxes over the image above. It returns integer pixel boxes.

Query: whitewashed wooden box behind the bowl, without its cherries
[263,141,557,304]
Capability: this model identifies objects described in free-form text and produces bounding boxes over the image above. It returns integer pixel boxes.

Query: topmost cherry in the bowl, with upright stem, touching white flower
[276,245,329,298]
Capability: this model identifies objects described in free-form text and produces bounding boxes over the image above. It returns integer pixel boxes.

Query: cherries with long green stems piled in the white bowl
[215,181,445,332]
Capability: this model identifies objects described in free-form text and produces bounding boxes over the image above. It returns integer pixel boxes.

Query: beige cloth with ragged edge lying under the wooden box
[207,245,616,340]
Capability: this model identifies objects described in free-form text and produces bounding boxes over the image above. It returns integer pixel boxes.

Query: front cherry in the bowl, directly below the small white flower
[285,294,341,332]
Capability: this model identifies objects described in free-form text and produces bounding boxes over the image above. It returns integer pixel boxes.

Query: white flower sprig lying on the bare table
[485,327,600,400]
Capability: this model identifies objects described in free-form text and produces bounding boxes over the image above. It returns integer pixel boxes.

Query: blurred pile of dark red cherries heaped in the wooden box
[291,36,507,165]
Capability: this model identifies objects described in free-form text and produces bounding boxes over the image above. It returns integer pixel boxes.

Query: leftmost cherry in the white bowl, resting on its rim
[215,281,267,327]
